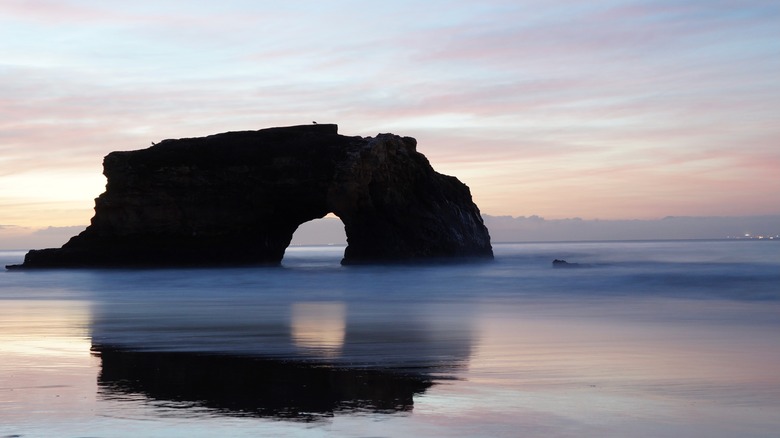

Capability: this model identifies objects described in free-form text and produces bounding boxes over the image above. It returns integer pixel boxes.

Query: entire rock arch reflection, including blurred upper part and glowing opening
[90,284,472,421]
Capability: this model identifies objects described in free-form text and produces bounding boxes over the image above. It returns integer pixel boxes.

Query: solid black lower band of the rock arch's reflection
[92,345,433,421]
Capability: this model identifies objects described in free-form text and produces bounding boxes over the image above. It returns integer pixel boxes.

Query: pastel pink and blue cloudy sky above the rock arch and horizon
[0,0,780,246]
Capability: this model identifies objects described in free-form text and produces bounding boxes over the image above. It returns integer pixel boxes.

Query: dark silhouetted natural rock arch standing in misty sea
[12,125,493,267]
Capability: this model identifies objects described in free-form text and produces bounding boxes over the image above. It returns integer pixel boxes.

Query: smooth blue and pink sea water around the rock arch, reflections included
[0,241,780,437]
